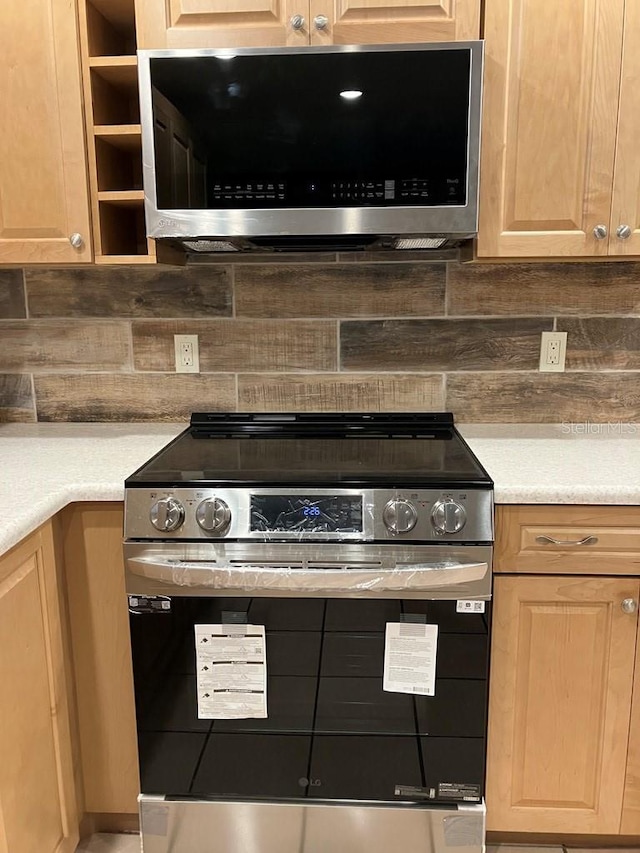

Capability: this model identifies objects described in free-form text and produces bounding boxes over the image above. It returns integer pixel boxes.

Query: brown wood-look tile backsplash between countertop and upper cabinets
[0,253,640,423]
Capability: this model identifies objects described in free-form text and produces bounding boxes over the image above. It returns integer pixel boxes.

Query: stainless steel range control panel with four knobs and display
[125,488,493,542]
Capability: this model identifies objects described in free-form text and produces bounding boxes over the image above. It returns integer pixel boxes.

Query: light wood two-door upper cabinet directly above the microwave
[136,0,480,49]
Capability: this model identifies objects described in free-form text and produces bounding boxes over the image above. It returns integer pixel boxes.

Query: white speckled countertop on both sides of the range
[0,423,640,554]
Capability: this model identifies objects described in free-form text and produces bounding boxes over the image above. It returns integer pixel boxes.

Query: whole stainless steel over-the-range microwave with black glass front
[138,41,483,252]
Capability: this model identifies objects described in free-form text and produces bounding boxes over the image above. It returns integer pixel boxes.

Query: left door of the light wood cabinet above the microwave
[136,0,309,50]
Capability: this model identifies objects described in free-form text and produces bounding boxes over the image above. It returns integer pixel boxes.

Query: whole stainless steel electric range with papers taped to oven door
[124,413,493,853]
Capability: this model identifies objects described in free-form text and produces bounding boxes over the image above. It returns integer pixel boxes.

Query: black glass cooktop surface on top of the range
[126,413,493,488]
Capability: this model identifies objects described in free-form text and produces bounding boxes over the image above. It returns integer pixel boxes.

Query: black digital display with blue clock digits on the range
[251,495,362,533]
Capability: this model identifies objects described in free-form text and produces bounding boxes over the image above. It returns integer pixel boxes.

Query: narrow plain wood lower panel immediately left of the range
[62,504,140,814]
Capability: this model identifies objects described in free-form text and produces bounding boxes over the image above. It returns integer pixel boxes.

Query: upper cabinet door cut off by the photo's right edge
[610,0,640,255]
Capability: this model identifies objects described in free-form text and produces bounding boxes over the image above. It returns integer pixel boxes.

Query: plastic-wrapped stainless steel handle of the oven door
[127,557,489,593]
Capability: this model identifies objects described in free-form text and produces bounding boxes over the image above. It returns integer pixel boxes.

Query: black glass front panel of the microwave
[150,46,471,210]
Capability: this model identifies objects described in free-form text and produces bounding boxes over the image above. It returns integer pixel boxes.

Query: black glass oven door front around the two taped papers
[130,597,489,802]
